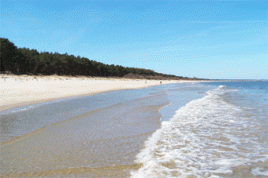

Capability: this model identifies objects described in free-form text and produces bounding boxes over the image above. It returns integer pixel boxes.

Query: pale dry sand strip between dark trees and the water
[0,74,192,111]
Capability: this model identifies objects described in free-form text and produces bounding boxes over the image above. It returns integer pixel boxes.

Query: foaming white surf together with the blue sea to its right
[131,80,268,178]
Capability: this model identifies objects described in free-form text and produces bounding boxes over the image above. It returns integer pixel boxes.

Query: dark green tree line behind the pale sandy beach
[0,38,187,79]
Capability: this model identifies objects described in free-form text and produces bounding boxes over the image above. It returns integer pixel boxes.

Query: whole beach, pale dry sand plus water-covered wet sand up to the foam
[0,75,198,177]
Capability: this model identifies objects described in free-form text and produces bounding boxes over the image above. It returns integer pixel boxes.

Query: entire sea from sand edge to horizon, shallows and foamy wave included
[0,80,268,178]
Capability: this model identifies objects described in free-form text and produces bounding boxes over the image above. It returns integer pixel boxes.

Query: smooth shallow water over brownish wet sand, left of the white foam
[0,83,169,177]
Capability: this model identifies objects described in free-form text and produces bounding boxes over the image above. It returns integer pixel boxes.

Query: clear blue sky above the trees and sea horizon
[0,0,268,79]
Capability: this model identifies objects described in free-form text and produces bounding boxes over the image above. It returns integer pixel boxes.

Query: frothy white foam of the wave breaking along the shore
[131,86,267,178]
